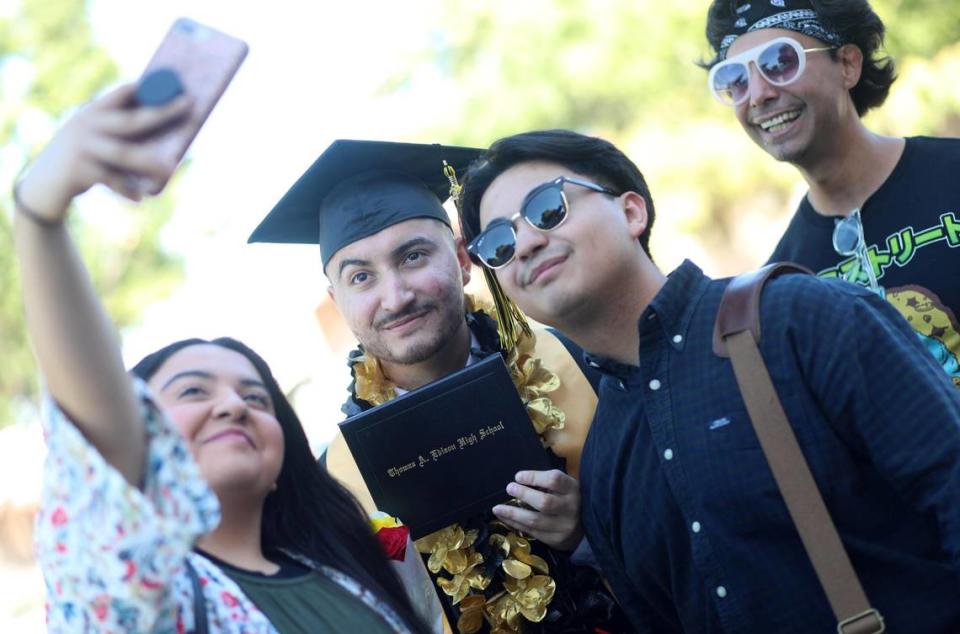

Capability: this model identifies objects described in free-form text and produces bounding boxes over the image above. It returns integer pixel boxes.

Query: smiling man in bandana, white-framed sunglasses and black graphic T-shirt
[707,0,960,387]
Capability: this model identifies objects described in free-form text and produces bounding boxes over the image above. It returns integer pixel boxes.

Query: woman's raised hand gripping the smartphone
[17,84,191,222]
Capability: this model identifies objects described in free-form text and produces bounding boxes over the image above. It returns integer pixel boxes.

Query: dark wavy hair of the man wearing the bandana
[701,0,897,117]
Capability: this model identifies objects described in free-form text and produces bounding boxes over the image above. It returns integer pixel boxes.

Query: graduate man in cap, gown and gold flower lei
[250,140,629,633]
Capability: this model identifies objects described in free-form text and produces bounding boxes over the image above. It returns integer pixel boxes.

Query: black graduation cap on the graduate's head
[247,139,483,268]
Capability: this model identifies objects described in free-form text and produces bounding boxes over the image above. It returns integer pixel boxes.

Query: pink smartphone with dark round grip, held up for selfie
[135,18,249,194]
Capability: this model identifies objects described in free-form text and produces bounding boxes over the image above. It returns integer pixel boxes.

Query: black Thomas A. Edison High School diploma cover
[340,354,552,539]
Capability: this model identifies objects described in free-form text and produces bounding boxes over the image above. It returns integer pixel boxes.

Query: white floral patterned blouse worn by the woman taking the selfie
[35,380,406,634]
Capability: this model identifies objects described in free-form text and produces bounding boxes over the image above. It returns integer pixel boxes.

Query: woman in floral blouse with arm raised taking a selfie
[14,85,423,633]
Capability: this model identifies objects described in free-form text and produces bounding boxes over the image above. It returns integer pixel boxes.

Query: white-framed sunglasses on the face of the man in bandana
[707,37,837,106]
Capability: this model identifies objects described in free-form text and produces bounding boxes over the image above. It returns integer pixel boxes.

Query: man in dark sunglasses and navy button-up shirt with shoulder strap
[461,131,960,634]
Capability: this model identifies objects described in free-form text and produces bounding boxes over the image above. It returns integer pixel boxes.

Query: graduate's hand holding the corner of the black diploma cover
[493,469,583,550]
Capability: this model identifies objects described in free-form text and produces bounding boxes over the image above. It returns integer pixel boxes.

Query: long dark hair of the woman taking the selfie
[130,337,425,631]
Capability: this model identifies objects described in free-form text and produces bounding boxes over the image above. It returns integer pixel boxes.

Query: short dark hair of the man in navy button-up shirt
[460,130,654,256]
